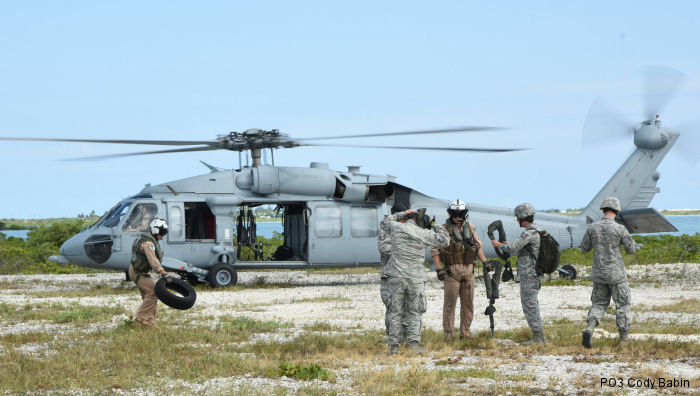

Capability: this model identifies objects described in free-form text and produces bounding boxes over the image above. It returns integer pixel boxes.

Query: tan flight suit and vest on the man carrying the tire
[129,234,165,326]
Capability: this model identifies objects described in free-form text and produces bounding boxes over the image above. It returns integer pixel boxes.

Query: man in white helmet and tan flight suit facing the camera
[430,199,486,341]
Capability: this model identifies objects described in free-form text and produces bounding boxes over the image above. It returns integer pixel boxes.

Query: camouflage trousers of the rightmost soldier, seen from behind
[588,280,632,331]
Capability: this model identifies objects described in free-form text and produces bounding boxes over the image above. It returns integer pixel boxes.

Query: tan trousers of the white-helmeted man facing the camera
[442,264,474,339]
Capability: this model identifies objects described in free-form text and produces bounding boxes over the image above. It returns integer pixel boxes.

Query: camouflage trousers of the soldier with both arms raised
[388,276,427,345]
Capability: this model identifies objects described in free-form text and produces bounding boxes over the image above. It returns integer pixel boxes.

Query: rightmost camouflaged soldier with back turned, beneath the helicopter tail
[581,197,637,348]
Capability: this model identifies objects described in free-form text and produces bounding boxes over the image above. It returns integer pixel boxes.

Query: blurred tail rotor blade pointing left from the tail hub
[581,98,634,148]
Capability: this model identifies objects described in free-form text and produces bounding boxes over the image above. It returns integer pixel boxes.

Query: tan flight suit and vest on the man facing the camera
[431,220,481,340]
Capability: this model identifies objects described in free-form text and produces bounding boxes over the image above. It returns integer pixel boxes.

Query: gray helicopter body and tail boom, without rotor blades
[52,125,679,280]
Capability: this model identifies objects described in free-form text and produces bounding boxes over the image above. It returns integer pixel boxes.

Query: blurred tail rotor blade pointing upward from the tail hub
[644,66,685,120]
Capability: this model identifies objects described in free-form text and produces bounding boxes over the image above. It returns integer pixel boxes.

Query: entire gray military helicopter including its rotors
[0,68,680,287]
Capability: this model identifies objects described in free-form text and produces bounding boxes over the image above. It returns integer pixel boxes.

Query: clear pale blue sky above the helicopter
[0,1,700,218]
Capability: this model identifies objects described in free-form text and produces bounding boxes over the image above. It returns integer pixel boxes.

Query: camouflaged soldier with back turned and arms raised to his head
[381,209,450,354]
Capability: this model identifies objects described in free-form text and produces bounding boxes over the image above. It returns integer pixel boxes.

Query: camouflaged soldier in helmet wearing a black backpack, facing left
[491,203,547,344]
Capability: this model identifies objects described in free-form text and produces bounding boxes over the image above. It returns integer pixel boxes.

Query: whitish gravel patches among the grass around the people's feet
[0,264,700,394]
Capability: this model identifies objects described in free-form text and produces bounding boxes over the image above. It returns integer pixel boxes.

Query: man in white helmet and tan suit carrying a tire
[129,218,168,327]
